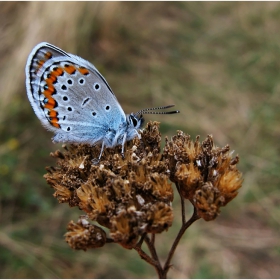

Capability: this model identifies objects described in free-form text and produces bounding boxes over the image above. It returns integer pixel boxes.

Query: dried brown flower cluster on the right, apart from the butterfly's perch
[163,131,242,221]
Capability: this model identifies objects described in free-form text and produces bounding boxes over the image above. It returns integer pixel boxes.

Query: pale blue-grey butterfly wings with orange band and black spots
[26,43,126,147]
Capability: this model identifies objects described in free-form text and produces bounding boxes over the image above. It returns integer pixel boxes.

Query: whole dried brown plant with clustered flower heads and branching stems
[45,122,242,278]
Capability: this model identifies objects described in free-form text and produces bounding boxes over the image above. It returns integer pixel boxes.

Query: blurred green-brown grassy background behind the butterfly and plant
[0,2,280,278]
